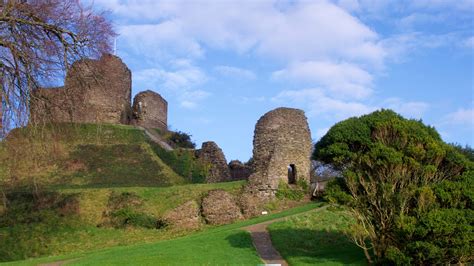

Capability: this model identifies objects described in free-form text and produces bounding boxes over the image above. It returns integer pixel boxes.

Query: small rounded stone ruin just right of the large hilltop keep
[132,90,168,129]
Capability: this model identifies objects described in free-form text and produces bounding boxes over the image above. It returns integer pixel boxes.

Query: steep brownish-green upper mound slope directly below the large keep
[0,124,185,187]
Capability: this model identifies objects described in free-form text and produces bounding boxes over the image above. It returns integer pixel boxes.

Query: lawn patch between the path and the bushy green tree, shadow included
[268,208,366,265]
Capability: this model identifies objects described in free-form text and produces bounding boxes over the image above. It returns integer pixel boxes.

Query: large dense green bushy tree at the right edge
[313,110,474,264]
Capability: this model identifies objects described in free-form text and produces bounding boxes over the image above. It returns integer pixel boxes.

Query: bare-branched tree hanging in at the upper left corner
[0,0,115,133]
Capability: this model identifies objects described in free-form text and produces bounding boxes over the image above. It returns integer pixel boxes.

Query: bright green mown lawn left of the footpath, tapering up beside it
[6,203,320,265]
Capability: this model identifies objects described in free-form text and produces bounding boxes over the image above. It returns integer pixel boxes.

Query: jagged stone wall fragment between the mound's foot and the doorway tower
[196,141,230,183]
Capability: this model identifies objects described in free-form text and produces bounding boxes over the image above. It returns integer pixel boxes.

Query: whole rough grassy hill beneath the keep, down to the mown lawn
[0,124,244,261]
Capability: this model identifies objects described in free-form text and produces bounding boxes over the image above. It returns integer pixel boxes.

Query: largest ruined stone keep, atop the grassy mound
[30,54,132,124]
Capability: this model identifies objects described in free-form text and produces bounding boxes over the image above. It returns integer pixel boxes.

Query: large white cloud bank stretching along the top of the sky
[100,0,384,64]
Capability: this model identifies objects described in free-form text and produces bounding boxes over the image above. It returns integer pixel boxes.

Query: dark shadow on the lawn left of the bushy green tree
[270,228,367,265]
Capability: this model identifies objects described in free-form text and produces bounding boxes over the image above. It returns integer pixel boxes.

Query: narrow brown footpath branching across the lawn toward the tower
[242,205,329,266]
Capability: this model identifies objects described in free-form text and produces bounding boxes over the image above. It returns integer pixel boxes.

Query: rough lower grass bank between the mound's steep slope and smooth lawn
[0,181,245,261]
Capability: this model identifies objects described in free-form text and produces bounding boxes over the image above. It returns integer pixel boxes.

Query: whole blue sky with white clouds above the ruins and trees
[88,0,474,161]
